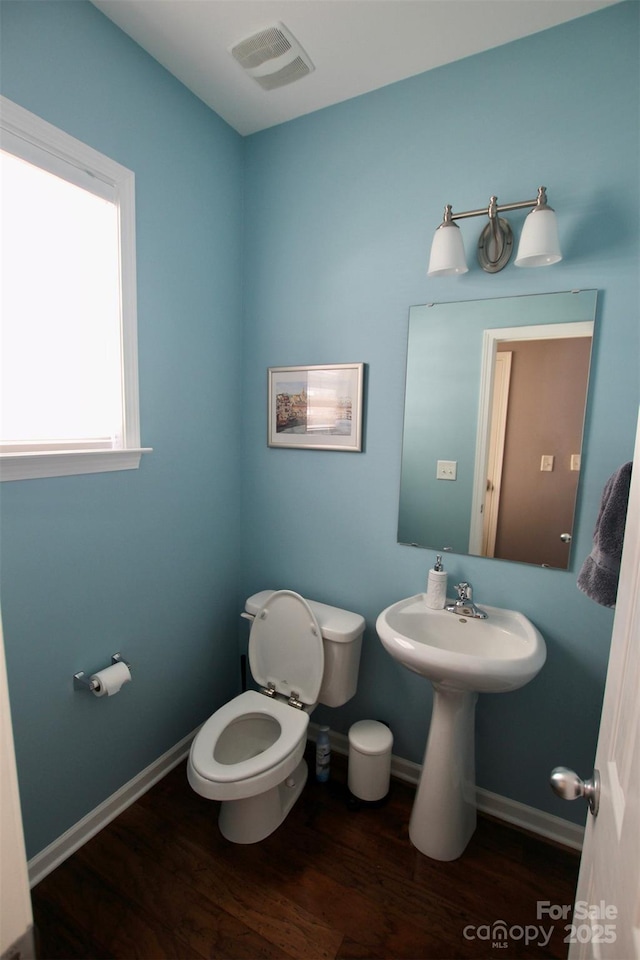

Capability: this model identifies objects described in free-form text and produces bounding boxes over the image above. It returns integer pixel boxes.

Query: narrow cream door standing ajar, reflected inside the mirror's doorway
[482,350,513,557]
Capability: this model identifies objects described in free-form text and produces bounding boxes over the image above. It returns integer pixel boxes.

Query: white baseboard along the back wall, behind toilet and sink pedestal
[309,723,584,850]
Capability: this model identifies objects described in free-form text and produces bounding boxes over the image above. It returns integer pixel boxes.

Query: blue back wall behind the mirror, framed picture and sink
[243,3,640,819]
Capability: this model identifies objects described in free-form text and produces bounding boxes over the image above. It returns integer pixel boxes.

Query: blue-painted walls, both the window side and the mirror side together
[0,0,640,856]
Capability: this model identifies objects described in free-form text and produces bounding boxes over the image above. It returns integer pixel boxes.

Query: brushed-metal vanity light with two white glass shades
[427,187,562,277]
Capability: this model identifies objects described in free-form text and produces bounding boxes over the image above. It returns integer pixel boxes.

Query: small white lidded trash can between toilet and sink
[348,720,393,802]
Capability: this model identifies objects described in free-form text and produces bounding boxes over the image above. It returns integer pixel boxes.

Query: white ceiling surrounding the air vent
[93,0,619,135]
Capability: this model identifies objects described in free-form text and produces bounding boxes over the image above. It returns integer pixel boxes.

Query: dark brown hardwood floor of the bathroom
[33,755,578,960]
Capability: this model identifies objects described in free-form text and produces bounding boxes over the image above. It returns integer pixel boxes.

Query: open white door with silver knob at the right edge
[567,421,640,960]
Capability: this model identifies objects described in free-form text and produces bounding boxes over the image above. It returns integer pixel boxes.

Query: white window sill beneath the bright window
[0,447,152,480]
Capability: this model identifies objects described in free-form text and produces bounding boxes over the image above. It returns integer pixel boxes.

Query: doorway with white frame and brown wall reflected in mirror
[469,321,593,570]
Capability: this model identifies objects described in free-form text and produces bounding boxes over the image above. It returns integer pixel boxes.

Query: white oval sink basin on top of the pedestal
[376,594,547,693]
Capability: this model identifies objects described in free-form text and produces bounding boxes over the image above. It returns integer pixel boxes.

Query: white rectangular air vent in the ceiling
[230,23,315,90]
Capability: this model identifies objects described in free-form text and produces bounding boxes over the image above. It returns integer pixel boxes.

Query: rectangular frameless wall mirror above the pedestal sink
[398,290,597,570]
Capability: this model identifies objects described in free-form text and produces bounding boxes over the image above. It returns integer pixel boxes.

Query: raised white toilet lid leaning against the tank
[249,590,324,705]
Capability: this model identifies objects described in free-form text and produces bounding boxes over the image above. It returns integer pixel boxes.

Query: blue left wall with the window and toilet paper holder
[0,2,243,856]
